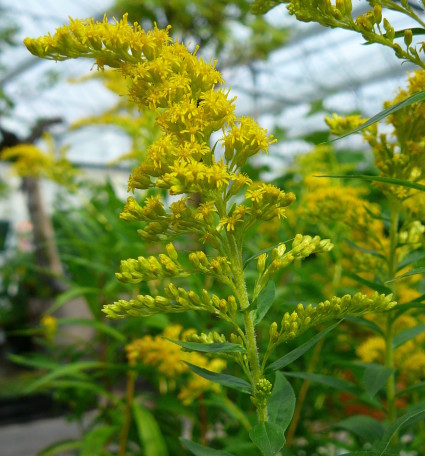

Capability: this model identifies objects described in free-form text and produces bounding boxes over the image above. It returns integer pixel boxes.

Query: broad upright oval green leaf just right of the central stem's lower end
[267,372,296,432]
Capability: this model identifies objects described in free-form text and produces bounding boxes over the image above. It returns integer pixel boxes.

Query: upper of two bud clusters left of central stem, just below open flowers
[115,243,189,283]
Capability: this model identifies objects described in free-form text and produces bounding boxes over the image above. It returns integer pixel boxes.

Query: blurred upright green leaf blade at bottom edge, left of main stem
[133,402,168,456]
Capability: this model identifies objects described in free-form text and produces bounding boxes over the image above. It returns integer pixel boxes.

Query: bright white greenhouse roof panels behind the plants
[0,0,418,165]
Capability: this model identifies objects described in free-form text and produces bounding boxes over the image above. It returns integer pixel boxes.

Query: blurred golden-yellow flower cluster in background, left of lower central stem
[126,325,226,405]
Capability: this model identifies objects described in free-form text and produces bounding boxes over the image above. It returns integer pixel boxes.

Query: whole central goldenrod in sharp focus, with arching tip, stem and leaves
[25,15,395,455]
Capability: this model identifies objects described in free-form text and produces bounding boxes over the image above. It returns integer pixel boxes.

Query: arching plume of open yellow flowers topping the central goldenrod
[25,15,288,253]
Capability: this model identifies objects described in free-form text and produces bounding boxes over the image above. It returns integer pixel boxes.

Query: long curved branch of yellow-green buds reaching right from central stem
[270,293,397,345]
